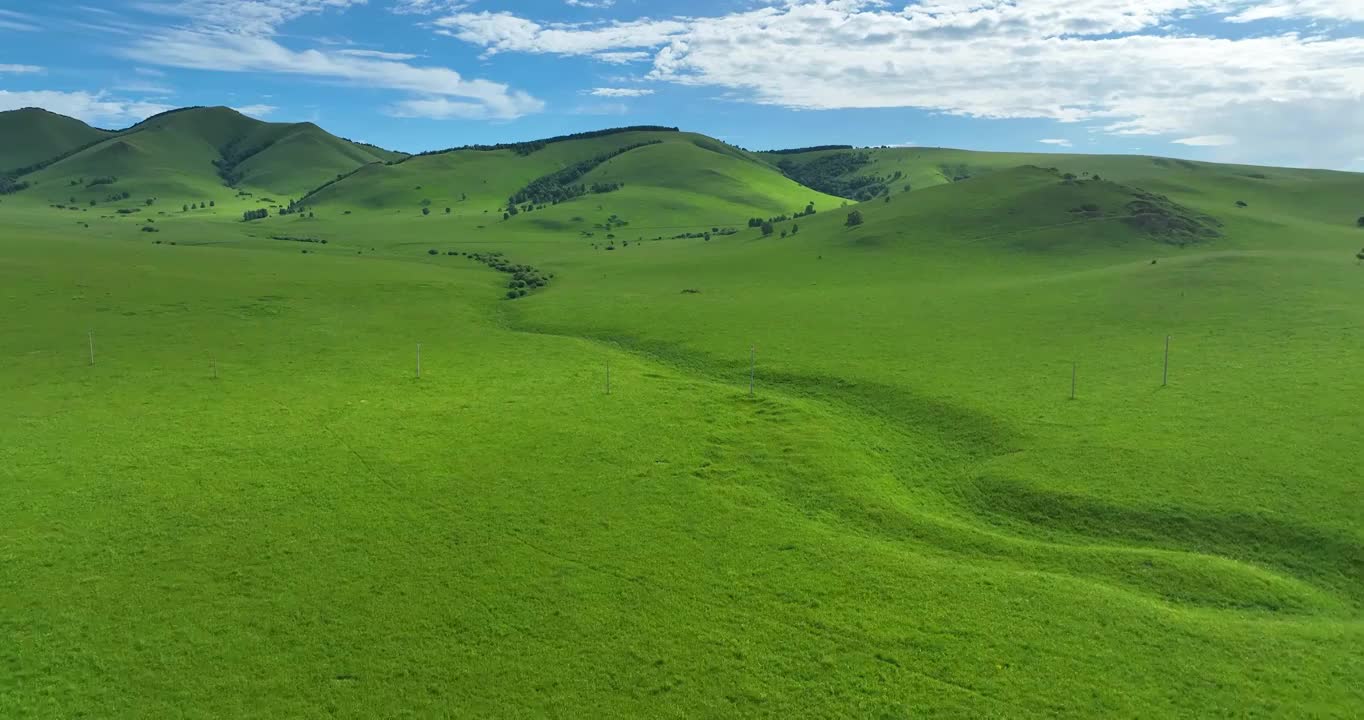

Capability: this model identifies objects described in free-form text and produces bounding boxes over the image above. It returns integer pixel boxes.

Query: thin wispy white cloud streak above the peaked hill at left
[121,0,544,119]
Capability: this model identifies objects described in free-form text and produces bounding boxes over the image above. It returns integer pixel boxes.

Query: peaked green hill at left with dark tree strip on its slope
[20,108,394,207]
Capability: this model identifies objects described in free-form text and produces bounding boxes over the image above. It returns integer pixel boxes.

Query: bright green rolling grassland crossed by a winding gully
[0,108,1364,717]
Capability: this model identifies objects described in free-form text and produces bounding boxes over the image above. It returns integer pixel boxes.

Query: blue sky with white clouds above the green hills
[0,0,1364,170]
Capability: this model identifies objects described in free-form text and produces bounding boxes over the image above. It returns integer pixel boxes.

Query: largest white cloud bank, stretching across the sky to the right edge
[435,0,1364,162]
